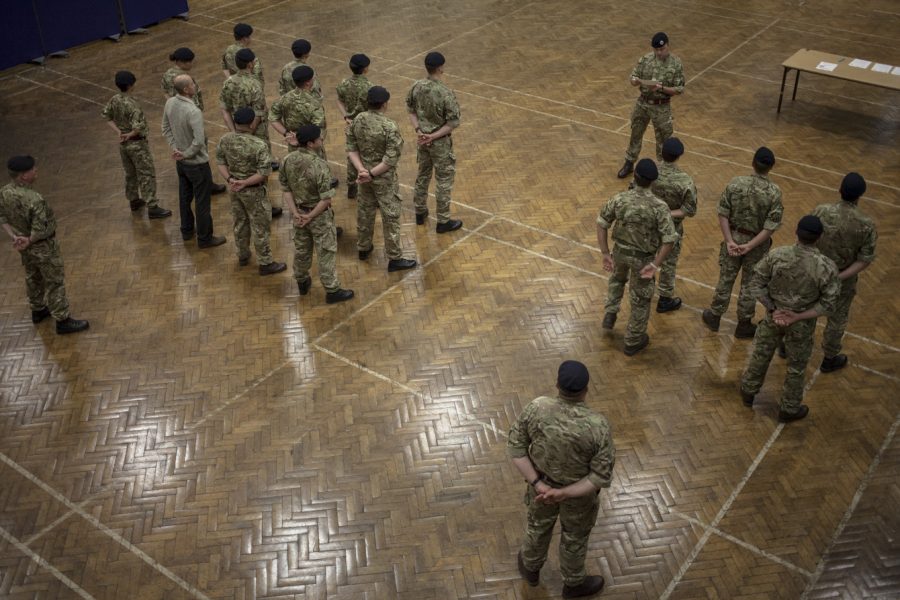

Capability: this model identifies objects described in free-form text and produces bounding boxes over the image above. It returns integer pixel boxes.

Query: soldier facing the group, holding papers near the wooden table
[618,31,684,179]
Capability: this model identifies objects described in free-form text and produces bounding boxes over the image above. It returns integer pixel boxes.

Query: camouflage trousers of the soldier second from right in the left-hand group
[356,169,403,260]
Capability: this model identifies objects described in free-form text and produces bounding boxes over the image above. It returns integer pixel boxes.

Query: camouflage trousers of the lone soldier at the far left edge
[19,238,69,321]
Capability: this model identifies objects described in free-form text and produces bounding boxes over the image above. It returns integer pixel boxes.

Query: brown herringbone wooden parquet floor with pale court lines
[0,0,900,600]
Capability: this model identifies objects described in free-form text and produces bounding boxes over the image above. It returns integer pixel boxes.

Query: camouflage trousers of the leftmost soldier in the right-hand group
[606,247,656,346]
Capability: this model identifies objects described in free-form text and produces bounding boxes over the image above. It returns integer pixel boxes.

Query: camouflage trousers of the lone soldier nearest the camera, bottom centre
[522,485,600,586]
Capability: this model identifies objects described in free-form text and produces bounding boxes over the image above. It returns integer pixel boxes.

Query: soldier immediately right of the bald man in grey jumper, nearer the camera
[216,107,287,275]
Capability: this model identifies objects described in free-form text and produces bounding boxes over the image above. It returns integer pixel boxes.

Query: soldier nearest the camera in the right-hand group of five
[741,215,841,422]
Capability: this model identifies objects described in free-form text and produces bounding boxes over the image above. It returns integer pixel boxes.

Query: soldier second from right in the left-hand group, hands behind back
[347,85,416,271]
